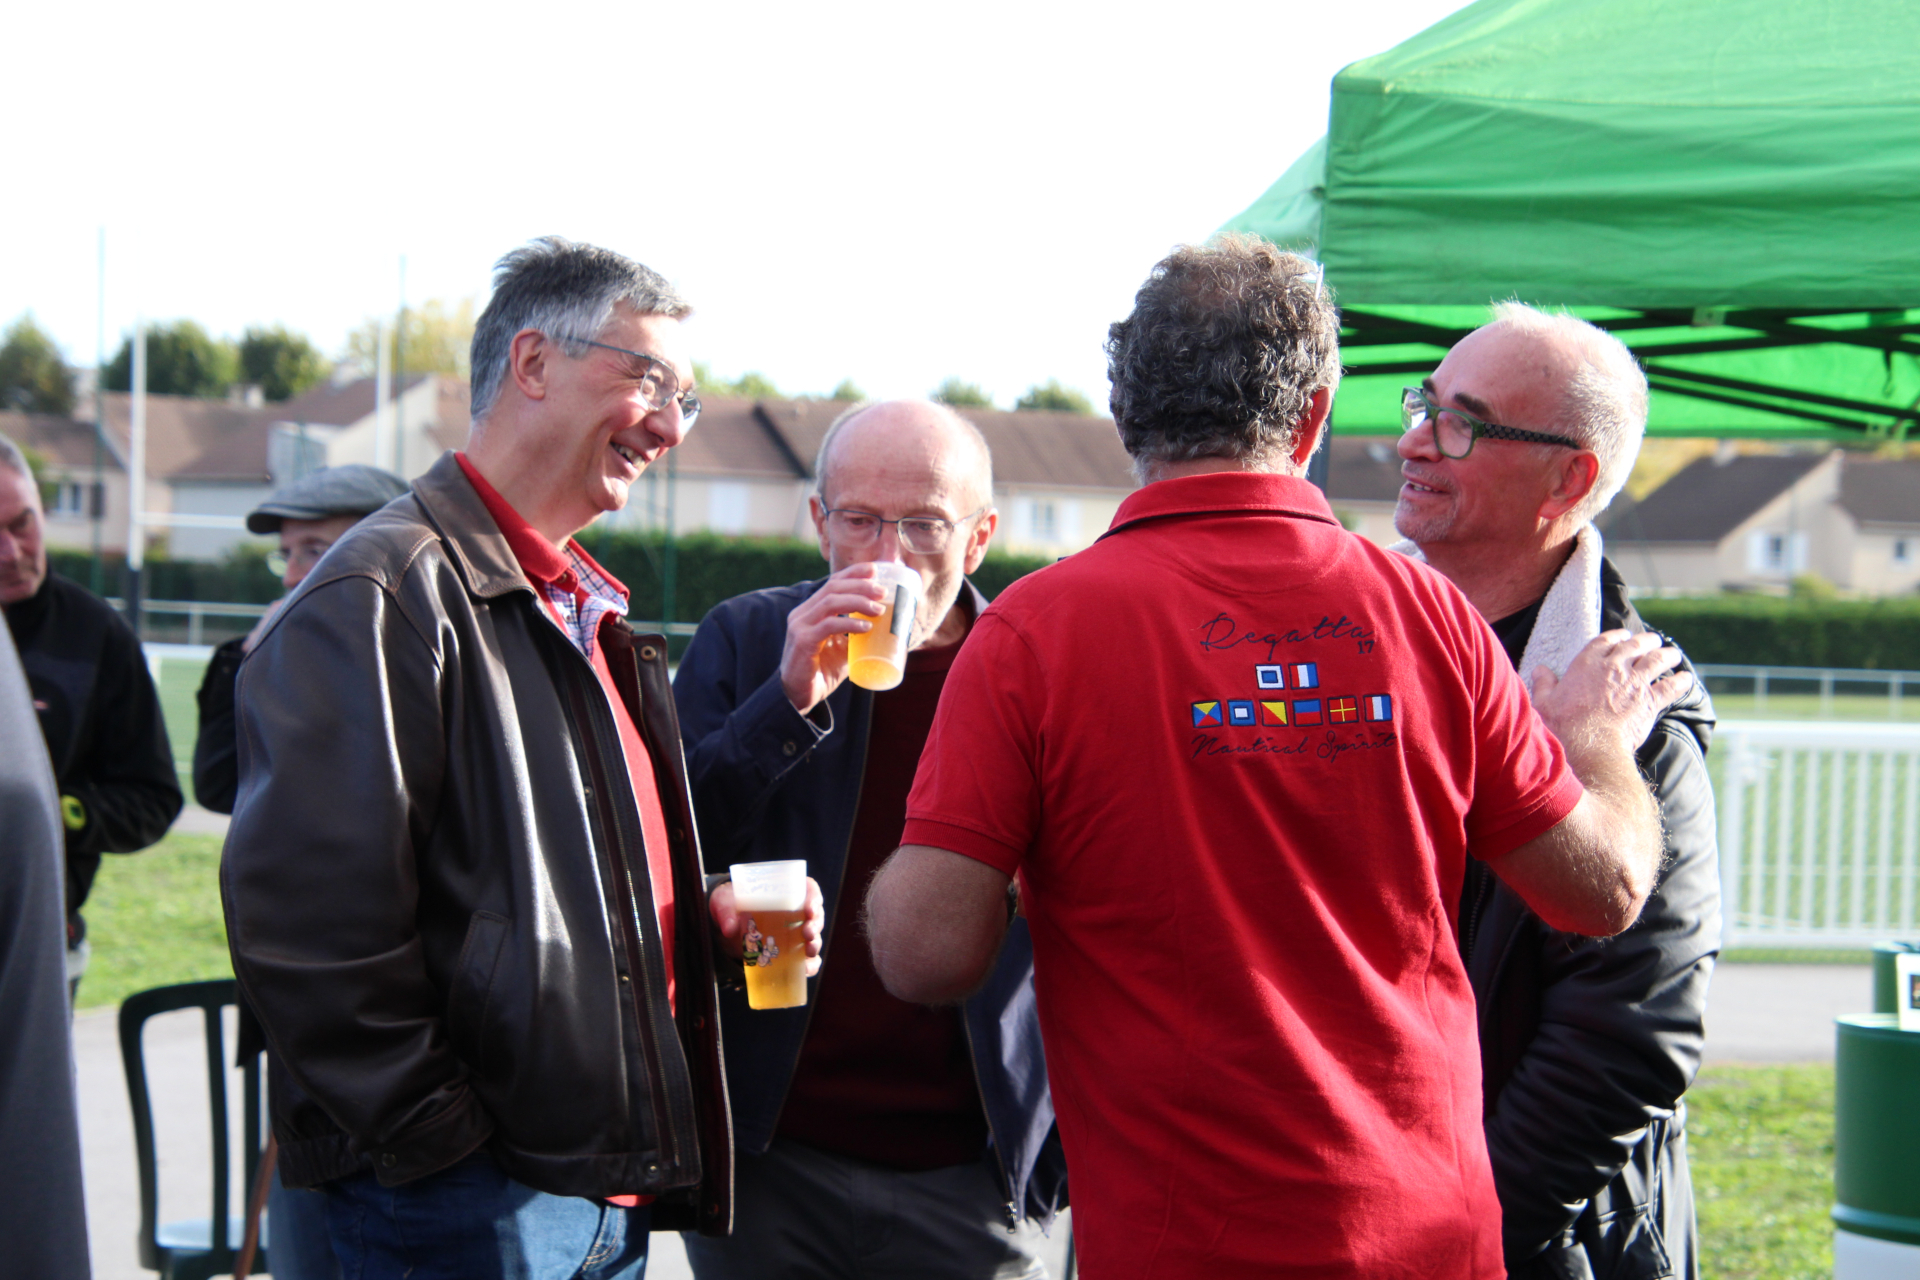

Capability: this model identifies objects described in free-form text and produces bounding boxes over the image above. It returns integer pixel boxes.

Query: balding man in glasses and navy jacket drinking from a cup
[674,401,1066,1280]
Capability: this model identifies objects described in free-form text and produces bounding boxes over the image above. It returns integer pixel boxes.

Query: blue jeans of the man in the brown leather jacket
[326,1151,651,1280]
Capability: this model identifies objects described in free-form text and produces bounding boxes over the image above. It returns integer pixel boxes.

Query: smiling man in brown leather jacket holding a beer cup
[221,238,820,1280]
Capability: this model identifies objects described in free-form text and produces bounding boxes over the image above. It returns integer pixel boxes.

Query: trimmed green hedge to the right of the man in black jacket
[1634,595,1920,672]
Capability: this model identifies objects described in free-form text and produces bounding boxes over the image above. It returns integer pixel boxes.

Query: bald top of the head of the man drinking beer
[814,399,993,510]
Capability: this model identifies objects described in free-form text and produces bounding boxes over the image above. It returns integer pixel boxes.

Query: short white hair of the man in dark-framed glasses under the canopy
[1488,301,1647,524]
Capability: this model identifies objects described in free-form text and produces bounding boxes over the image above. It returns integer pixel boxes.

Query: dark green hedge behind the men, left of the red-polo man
[48,530,1052,622]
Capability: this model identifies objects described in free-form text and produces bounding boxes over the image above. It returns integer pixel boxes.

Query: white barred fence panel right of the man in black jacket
[1709,720,1920,946]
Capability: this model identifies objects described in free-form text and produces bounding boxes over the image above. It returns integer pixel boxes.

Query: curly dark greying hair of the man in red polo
[1106,234,1340,478]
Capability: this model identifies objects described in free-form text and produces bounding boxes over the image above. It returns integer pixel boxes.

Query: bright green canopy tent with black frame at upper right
[1223,0,1920,439]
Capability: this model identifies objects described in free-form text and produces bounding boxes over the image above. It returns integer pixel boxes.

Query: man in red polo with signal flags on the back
[868,238,1676,1280]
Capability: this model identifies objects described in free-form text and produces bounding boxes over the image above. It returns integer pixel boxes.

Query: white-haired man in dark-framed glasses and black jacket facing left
[1394,303,1720,1278]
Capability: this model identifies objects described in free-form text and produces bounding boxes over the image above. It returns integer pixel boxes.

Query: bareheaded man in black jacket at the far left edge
[0,436,182,994]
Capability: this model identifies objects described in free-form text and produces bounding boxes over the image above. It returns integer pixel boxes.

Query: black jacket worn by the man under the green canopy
[1461,562,1720,1278]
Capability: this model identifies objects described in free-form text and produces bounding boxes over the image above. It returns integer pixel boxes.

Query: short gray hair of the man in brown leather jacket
[468,236,693,422]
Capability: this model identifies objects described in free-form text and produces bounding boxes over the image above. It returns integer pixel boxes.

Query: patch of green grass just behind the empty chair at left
[81,833,232,1009]
